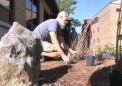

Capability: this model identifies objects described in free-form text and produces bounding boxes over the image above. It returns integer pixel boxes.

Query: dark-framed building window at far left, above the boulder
[0,0,13,24]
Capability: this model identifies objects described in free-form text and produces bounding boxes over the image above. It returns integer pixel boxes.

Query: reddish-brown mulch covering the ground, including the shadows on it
[38,57,115,86]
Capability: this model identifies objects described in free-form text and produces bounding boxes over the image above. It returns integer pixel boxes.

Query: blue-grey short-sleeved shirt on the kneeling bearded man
[34,19,61,41]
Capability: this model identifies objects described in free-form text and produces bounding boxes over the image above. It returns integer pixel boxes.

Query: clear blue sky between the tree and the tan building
[70,0,114,33]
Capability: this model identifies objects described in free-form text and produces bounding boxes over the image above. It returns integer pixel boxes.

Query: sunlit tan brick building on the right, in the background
[90,0,121,49]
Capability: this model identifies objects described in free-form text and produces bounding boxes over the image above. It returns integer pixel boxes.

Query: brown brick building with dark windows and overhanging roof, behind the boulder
[0,0,60,40]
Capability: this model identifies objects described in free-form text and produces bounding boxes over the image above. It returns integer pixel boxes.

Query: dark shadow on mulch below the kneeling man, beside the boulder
[38,65,72,86]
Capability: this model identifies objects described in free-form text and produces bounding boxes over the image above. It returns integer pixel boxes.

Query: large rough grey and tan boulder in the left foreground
[0,22,42,86]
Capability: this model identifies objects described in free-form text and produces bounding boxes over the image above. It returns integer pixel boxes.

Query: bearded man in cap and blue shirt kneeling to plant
[34,11,77,64]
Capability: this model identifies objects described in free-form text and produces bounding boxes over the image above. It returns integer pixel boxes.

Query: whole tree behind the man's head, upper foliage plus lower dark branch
[57,0,81,27]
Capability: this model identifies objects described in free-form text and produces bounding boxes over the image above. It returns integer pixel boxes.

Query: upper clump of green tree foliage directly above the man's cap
[57,0,77,14]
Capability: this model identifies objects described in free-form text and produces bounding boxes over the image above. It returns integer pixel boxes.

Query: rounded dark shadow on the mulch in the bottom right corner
[87,65,115,86]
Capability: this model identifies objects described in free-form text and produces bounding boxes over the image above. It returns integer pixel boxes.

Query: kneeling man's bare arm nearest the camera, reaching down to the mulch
[49,31,69,63]
